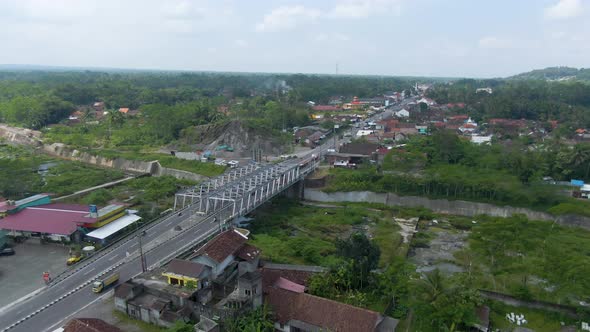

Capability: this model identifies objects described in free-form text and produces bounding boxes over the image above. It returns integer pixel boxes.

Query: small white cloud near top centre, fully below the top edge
[256,5,321,31]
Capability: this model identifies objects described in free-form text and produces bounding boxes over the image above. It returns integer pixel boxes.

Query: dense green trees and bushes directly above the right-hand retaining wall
[326,131,590,216]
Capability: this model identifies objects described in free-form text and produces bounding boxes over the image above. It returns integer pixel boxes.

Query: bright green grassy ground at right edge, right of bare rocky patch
[465,216,590,305]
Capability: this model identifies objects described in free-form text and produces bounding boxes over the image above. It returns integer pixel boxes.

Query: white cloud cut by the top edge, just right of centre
[328,0,401,19]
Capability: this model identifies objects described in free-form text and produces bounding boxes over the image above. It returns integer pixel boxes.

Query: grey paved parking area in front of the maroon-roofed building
[0,240,68,308]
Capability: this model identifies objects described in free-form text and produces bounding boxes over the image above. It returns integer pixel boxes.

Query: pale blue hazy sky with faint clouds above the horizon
[0,0,590,78]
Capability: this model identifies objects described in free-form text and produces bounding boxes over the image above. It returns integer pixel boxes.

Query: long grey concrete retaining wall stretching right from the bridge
[304,188,590,230]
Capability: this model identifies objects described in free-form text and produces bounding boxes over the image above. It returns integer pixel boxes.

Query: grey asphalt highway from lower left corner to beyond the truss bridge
[0,140,334,332]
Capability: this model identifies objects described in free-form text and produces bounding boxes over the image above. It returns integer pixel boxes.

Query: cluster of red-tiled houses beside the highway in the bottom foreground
[115,229,397,332]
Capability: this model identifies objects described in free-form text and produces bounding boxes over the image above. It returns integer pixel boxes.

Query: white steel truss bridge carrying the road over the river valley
[174,155,319,222]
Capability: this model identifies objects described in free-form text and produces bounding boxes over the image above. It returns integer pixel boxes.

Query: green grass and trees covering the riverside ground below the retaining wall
[250,199,590,331]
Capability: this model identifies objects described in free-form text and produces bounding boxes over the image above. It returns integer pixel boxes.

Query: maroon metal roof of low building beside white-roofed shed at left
[0,204,96,235]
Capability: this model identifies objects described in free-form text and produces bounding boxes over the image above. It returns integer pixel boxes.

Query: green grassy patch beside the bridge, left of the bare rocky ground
[250,199,406,266]
